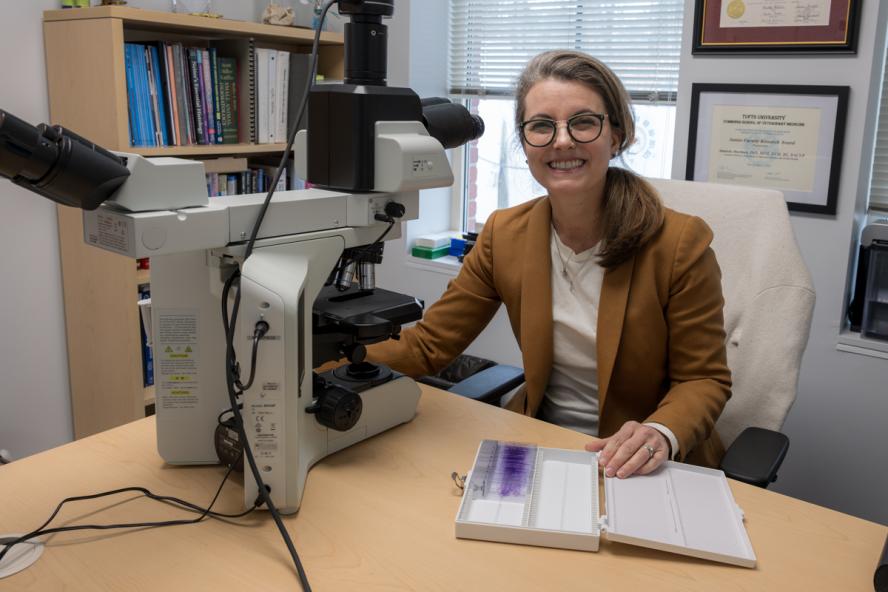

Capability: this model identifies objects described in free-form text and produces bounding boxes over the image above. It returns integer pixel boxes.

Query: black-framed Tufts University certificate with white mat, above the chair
[685,84,849,214]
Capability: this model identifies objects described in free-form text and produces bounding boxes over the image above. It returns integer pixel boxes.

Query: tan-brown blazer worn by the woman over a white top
[368,197,731,466]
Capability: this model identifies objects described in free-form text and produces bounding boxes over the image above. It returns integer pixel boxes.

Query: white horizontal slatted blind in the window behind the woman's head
[449,0,684,102]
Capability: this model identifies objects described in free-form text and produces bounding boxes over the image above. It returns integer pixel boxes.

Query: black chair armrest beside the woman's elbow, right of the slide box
[721,428,789,487]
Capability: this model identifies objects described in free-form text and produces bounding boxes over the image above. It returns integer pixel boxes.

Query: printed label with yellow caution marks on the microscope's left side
[154,309,200,409]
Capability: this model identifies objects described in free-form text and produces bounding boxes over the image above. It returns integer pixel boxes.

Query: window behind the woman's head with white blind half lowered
[449,0,684,231]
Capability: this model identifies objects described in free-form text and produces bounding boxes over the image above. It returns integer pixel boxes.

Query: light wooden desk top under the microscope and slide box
[0,388,888,592]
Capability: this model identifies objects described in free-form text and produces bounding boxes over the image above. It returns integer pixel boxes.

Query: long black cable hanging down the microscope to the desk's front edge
[222,0,337,592]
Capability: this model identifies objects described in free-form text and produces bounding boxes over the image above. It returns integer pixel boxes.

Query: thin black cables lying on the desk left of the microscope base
[0,466,253,561]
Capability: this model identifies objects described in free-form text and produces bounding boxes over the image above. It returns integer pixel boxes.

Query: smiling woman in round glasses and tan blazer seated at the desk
[368,51,731,477]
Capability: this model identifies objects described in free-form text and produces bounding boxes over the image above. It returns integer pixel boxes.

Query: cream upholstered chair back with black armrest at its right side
[649,179,814,487]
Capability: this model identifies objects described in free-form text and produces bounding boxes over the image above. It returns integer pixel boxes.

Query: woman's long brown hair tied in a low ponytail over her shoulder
[515,50,663,268]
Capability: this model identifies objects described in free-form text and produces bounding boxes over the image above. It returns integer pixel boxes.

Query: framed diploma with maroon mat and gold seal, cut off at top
[692,0,863,53]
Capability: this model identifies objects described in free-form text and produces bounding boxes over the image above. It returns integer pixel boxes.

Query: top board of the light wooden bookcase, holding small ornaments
[43,6,343,45]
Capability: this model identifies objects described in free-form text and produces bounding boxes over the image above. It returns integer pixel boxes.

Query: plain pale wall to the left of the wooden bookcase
[0,0,73,458]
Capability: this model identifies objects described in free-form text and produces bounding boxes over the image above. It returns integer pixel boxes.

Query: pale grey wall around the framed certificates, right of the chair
[672,0,888,524]
